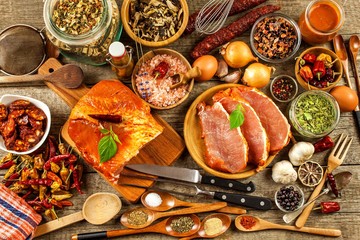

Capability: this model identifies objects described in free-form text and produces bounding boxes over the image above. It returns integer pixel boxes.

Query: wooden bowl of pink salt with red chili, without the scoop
[131,48,194,110]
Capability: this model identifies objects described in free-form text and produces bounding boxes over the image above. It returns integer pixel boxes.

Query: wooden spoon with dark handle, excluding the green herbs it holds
[71,214,200,240]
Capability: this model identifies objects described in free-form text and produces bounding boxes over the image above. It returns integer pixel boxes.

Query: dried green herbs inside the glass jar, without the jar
[295,95,335,134]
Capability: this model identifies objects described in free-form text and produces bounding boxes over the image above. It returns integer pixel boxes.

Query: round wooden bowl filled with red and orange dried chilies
[295,47,343,91]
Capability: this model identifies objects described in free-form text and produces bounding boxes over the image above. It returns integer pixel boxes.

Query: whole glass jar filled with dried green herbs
[288,90,340,139]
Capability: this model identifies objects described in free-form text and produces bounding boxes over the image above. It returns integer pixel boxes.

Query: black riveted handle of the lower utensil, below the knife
[214,192,272,210]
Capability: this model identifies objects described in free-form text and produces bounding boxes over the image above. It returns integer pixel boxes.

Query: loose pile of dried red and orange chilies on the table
[0,137,83,219]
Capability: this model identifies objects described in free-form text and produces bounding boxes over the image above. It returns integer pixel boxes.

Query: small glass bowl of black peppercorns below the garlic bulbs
[275,185,304,212]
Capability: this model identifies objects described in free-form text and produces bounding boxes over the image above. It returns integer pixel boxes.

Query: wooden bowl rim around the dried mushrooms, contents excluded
[120,0,189,47]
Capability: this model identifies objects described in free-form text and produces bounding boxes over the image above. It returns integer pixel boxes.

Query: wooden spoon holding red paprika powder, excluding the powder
[235,215,341,237]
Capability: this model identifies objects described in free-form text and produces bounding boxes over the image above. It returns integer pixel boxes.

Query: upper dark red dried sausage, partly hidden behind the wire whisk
[184,0,267,34]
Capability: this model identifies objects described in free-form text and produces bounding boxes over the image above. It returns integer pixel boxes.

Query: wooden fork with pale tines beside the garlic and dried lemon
[295,134,353,228]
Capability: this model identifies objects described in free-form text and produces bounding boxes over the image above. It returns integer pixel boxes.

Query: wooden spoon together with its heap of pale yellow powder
[180,213,231,240]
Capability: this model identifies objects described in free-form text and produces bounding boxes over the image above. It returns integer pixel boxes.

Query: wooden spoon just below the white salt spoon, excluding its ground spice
[120,202,227,228]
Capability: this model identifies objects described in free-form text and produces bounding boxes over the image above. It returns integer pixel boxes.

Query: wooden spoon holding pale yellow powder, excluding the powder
[180,213,231,240]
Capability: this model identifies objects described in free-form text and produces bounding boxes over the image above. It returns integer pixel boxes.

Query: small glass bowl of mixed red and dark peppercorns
[270,75,298,102]
